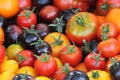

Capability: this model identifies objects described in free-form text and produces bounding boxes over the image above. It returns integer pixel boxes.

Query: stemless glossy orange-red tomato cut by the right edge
[97,38,120,58]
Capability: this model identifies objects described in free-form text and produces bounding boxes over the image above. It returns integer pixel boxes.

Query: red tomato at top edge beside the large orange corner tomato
[19,0,32,11]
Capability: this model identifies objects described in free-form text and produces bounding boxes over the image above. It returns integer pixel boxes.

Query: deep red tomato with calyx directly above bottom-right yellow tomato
[84,52,106,70]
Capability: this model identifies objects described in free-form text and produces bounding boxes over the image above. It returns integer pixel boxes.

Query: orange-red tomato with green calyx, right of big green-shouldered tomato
[97,22,119,40]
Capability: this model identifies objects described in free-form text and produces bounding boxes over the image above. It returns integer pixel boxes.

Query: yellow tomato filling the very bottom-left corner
[0,71,15,80]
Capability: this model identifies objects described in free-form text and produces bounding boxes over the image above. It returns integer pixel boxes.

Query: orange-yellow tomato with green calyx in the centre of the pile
[43,32,70,57]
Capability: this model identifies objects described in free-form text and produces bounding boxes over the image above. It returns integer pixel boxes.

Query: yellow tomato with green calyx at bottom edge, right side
[87,70,112,80]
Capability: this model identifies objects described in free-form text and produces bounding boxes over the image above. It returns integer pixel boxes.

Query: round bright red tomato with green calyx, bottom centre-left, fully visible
[34,54,57,77]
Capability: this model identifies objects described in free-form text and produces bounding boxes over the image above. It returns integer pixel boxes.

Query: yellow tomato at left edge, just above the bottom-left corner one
[1,60,19,73]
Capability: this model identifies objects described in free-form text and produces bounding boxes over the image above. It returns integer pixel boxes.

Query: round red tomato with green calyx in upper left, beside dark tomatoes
[17,10,37,28]
